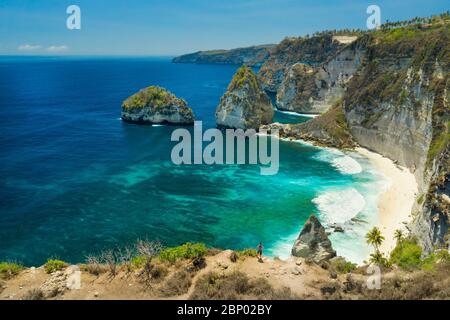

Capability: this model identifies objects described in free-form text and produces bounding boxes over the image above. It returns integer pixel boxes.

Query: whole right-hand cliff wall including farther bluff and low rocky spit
[260,18,450,252]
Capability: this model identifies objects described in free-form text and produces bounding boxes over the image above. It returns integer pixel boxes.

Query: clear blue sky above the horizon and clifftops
[0,0,450,55]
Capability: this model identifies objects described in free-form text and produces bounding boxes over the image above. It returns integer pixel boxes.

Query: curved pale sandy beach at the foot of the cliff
[356,148,418,254]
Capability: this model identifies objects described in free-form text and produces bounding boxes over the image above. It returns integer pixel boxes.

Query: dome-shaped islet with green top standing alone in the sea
[122,86,194,125]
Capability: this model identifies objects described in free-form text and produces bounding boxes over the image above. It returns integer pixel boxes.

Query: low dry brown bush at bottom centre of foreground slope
[189,272,296,300]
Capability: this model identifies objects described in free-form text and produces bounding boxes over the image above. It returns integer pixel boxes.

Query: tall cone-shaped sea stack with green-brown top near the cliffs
[216,66,274,130]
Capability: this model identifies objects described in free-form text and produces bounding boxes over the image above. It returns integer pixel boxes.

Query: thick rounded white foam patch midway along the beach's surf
[313,188,366,225]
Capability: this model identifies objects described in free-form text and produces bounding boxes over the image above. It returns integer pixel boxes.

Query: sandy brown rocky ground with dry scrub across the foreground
[0,250,450,300]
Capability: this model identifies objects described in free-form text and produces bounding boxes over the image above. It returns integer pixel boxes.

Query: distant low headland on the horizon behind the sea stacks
[172,44,275,66]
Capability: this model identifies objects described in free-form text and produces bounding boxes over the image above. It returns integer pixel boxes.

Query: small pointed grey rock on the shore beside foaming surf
[292,215,336,263]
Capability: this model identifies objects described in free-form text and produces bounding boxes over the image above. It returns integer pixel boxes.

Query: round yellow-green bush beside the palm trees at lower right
[390,240,422,270]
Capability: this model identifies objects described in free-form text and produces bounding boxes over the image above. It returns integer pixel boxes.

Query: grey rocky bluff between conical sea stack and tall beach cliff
[277,38,364,114]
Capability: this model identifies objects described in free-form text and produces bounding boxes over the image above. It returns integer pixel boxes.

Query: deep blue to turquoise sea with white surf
[0,57,382,265]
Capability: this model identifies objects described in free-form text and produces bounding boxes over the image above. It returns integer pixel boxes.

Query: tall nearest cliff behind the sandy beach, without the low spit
[343,24,450,251]
